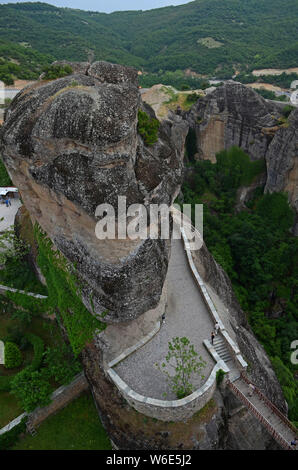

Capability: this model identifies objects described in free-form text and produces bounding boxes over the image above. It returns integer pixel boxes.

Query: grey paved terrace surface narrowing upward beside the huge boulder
[114,233,215,400]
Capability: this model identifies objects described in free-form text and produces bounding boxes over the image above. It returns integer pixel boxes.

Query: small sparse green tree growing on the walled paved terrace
[156,336,206,399]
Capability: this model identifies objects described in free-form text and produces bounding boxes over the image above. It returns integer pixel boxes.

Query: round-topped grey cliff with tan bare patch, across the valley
[186,82,280,162]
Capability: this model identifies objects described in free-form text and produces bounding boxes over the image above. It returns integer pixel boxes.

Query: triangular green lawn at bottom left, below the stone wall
[12,393,112,450]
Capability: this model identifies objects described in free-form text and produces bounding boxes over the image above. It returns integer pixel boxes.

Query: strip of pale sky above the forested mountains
[0,0,191,13]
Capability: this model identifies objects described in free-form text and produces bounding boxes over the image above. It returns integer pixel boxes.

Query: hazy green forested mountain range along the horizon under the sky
[0,0,298,74]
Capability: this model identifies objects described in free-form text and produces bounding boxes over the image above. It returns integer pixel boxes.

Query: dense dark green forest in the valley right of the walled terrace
[180,147,298,424]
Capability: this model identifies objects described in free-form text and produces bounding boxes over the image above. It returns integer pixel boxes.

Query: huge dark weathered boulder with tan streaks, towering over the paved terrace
[1,62,187,322]
